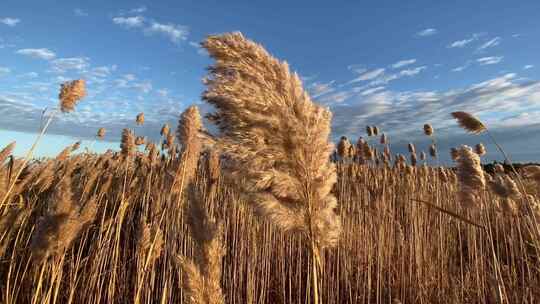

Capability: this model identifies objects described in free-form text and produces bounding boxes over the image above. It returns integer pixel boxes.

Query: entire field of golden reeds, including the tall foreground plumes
[0,33,540,304]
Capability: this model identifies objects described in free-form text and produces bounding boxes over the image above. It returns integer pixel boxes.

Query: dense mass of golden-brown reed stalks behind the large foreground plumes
[0,144,540,303]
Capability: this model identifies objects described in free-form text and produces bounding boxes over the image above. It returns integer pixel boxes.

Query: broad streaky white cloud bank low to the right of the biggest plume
[330,74,540,147]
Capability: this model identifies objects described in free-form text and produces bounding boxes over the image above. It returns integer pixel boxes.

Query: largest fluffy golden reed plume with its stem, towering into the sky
[202,33,341,303]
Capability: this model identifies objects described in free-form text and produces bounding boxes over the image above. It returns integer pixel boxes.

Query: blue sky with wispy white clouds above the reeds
[0,0,540,161]
